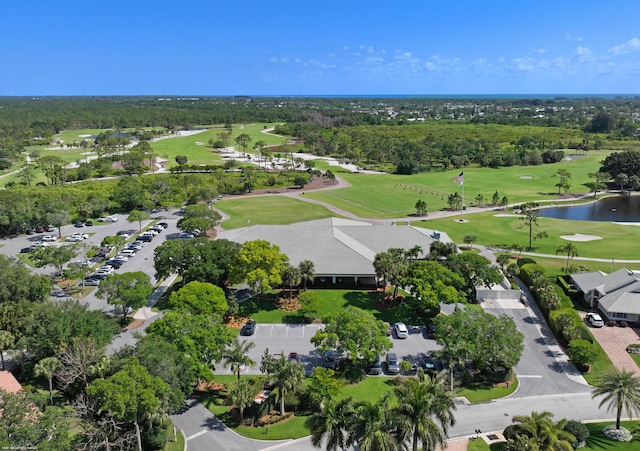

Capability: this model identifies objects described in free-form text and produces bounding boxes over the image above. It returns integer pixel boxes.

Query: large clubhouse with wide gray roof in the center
[218,218,451,285]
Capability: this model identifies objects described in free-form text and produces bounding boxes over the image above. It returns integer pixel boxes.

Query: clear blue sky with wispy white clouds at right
[0,0,640,95]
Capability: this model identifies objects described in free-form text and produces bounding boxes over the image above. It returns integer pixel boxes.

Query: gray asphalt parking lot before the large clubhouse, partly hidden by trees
[216,324,440,374]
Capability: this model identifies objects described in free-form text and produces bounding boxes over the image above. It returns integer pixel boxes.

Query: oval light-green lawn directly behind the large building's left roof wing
[216,196,336,230]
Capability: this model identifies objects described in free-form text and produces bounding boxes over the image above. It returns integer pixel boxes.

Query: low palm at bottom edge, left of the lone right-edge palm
[513,412,576,451]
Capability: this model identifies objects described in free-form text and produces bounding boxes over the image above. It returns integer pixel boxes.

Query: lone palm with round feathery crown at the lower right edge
[592,369,640,429]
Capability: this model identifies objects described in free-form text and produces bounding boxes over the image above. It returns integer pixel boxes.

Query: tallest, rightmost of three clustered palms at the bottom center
[395,370,456,451]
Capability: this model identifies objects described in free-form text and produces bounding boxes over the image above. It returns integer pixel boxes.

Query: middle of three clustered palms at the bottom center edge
[347,394,408,451]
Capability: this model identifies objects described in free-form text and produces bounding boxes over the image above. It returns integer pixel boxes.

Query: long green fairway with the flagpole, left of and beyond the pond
[305,152,607,219]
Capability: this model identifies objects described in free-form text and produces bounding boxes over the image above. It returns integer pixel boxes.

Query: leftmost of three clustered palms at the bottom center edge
[306,397,354,451]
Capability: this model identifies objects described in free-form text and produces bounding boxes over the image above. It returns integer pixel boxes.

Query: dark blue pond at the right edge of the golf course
[540,196,640,222]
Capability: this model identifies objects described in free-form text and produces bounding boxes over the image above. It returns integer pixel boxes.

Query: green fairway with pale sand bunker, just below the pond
[413,212,640,263]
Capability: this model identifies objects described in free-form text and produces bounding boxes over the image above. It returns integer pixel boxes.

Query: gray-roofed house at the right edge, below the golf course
[571,268,640,322]
